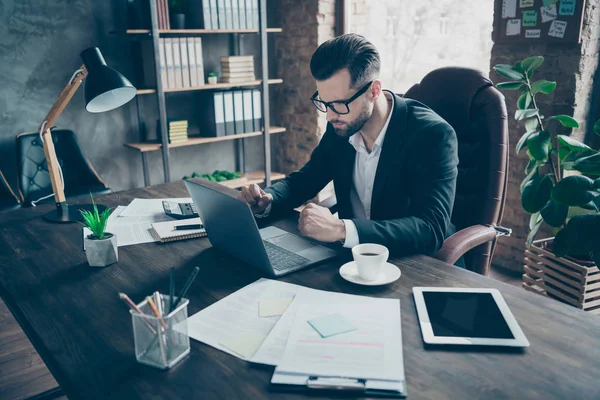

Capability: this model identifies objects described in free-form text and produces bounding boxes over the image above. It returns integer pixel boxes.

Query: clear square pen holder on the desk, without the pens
[130,294,190,369]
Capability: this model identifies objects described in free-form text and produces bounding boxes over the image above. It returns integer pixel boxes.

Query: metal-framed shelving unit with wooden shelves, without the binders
[124,0,286,187]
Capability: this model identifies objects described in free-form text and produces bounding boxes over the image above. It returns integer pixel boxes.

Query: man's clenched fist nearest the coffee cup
[298,203,346,242]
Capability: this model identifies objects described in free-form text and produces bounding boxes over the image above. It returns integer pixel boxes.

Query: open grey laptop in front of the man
[185,181,337,276]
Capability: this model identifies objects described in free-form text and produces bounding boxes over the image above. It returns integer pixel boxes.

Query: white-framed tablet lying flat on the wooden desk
[413,287,529,347]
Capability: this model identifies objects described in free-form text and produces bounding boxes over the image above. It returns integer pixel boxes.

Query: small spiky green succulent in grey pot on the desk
[81,197,119,267]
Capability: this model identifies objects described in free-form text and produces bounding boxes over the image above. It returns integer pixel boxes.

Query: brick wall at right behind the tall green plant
[490,0,600,271]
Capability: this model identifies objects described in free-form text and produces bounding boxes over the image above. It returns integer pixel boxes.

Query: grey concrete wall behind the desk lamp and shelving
[0,0,263,194]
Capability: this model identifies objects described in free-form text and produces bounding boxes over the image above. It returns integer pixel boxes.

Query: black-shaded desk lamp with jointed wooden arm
[39,47,136,222]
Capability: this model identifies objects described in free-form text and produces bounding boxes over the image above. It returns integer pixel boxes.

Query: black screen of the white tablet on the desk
[423,292,514,339]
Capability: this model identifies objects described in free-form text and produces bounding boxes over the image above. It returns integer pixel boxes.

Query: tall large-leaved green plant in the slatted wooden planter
[494,56,600,265]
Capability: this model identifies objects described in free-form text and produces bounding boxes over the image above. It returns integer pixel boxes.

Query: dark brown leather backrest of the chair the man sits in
[405,67,508,272]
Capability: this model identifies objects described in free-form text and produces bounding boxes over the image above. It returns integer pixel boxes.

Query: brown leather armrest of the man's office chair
[433,225,512,264]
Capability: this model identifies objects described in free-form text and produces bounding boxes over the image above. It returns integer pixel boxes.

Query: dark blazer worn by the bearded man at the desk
[266,94,458,255]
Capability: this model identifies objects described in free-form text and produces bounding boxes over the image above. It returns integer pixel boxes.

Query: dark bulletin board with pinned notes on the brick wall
[494,0,586,44]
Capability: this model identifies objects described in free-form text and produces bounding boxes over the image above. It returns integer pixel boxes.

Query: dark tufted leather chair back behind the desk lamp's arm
[17,129,110,205]
